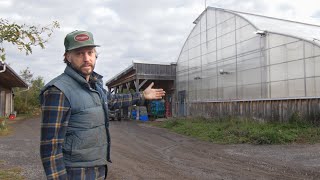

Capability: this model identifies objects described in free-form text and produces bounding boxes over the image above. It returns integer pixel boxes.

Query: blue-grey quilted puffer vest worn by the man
[42,66,111,167]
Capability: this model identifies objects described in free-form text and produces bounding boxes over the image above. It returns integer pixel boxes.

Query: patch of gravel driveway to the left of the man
[0,118,46,180]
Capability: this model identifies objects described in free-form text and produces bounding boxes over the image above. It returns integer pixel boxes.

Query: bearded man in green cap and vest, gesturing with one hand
[40,31,165,180]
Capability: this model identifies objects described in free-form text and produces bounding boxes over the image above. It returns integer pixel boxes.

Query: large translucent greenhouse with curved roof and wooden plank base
[175,7,320,120]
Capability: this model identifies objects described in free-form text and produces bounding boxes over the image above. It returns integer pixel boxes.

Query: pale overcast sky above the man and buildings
[0,0,320,86]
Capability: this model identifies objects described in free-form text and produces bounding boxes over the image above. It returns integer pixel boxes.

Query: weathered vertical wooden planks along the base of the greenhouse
[187,98,320,124]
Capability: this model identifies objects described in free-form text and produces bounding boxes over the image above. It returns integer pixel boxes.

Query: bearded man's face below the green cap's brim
[66,47,96,79]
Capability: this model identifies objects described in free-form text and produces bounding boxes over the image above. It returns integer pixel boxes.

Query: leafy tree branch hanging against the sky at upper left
[0,18,60,61]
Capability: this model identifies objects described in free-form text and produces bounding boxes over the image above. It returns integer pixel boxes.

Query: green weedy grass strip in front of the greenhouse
[152,118,320,144]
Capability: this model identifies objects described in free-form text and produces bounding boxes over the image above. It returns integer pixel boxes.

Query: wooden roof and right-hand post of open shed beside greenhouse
[106,61,176,116]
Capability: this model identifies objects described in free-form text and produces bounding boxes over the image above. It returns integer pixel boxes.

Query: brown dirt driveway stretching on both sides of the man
[0,119,320,180]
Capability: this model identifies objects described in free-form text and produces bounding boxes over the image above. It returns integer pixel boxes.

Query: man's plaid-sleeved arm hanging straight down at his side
[40,87,70,180]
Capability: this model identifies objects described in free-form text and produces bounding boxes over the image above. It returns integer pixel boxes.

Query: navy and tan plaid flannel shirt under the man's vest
[40,87,144,180]
